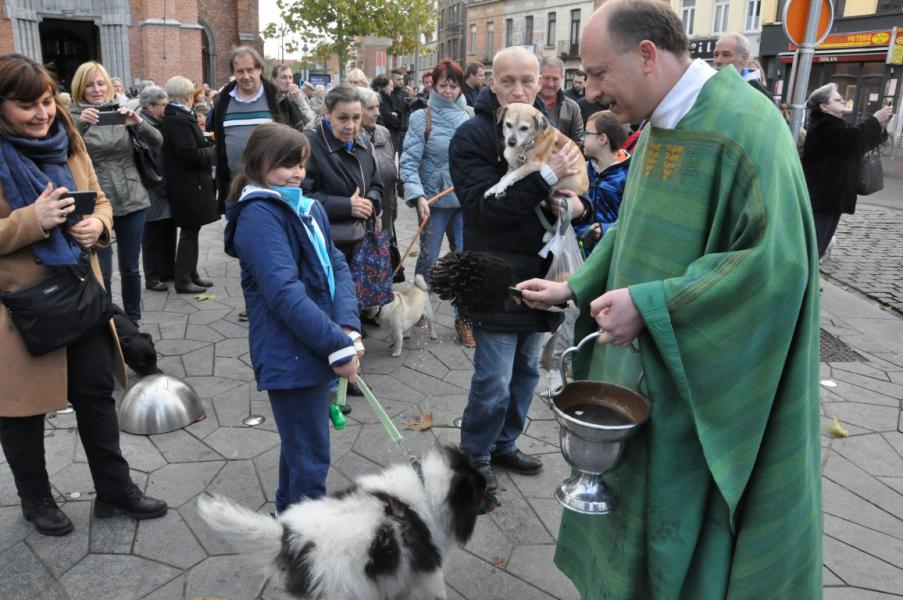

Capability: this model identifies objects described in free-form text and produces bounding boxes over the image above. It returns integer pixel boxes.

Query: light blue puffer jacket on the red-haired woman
[400,92,473,208]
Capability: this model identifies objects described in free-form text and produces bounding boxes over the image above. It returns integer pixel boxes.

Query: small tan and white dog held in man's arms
[483,102,589,197]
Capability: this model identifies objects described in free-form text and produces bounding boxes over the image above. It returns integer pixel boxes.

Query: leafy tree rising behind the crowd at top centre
[263,0,436,77]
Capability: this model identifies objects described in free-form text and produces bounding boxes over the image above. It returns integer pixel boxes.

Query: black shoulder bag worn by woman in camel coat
[0,257,113,356]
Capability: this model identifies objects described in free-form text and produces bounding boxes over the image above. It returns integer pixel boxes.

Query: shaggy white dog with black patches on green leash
[198,447,497,600]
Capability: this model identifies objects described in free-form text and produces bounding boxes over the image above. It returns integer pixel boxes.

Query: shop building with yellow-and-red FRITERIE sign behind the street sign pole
[761,0,903,122]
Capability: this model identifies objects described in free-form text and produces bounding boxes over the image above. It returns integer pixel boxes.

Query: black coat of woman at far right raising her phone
[802,110,887,214]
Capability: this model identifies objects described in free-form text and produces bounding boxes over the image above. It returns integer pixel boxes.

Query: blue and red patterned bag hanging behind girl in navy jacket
[348,218,392,309]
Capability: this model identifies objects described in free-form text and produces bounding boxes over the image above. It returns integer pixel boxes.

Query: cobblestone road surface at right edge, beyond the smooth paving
[821,204,903,314]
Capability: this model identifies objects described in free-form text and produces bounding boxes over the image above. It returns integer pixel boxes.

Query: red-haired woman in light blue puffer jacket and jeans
[400,59,476,347]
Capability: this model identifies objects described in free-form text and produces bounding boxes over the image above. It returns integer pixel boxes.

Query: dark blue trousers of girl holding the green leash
[267,381,332,512]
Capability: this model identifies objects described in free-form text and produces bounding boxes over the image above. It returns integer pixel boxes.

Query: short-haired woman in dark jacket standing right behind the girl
[301,84,383,260]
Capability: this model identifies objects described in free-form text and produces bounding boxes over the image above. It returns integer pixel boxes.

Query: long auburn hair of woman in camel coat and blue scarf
[0,54,85,156]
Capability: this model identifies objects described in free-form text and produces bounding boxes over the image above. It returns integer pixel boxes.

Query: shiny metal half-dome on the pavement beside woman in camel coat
[119,375,205,435]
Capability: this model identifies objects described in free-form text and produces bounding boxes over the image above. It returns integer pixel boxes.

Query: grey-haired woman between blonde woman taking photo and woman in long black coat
[138,85,177,292]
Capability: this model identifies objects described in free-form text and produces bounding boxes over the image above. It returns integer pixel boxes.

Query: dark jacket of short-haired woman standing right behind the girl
[301,118,383,244]
